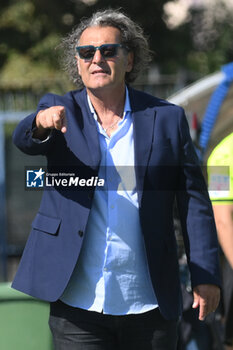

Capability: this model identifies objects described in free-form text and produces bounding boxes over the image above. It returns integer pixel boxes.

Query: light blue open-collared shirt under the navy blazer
[61,89,158,315]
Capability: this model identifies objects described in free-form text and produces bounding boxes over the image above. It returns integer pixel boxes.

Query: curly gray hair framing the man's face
[59,9,151,87]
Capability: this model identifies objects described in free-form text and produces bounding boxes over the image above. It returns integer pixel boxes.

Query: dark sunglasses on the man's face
[76,44,126,60]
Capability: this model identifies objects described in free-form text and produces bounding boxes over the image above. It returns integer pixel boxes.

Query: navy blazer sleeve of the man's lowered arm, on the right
[177,110,221,287]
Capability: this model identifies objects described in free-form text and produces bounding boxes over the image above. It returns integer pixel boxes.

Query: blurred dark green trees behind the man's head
[0,0,233,110]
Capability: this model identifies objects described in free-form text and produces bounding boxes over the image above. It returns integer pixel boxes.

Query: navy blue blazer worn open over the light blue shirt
[13,88,220,319]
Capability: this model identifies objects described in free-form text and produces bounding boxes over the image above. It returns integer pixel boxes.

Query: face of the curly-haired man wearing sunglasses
[76,26,133,91]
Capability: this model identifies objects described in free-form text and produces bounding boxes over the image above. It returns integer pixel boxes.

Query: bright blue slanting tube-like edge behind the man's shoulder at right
[199,63,233,154]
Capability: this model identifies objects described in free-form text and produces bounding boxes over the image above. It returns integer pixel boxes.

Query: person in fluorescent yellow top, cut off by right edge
[208,133,233,350]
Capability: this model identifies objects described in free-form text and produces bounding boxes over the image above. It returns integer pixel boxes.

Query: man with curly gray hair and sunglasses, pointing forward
[13,10,220,350]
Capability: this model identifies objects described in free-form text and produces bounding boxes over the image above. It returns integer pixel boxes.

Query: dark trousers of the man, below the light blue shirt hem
[49,301,178,350]
